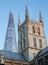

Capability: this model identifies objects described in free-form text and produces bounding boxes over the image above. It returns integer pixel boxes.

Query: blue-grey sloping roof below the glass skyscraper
[0,50,26,61]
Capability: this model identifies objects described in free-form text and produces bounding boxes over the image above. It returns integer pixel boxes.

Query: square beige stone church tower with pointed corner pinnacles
[18,7,46,61]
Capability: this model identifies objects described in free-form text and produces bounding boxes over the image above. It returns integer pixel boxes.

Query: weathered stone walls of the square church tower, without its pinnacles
[18,20,46,61]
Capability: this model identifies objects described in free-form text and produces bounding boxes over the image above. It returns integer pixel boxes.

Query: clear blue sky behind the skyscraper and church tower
[0,0,48,50]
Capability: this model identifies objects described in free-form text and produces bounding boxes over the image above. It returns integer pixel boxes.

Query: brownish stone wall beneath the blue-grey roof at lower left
[4,59,29,65]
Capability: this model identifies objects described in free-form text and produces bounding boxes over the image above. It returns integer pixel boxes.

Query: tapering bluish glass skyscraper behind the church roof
[4,12,16,52]
